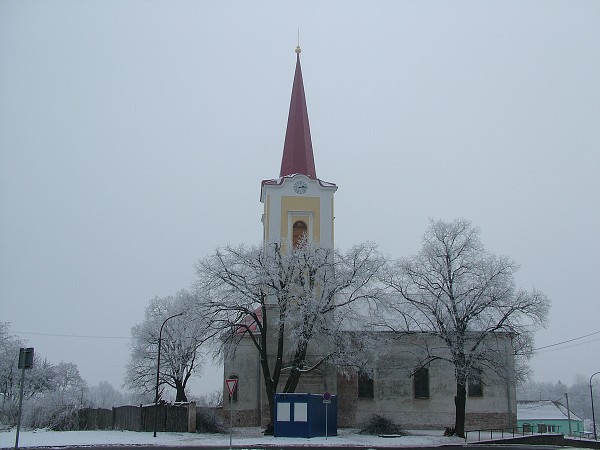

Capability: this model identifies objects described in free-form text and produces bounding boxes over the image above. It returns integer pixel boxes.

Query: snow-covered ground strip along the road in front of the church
[0,428,464,448]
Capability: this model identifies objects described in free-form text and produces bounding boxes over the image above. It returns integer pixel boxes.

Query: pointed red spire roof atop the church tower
[279,47,317,179]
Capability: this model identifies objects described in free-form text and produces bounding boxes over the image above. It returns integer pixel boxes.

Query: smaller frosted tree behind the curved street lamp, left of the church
[125,290,213,402]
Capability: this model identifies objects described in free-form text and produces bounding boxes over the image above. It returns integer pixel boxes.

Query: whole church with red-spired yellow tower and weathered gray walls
[223,47,516,430]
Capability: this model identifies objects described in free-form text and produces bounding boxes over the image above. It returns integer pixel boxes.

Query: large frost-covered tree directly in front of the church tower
[196,242,383,423]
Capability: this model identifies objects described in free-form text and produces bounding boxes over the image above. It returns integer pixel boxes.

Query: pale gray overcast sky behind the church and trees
[0,0,600,393]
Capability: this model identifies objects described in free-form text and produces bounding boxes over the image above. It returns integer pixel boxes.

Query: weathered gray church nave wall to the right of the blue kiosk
[338,335,516,429]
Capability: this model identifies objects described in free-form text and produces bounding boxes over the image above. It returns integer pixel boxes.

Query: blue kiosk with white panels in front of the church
[274,393,337,438]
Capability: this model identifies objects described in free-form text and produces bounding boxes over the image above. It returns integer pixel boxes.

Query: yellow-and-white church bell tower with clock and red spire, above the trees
[260,47,337,248]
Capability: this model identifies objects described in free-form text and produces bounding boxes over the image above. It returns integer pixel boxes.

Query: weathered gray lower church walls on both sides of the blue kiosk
[224,328,516,430]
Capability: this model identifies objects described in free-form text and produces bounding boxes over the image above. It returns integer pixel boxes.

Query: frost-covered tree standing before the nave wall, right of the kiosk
[382,219,550,437]
